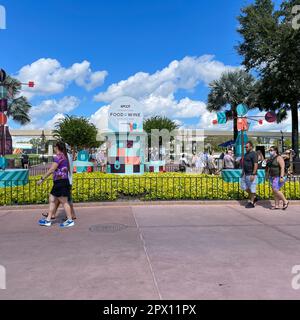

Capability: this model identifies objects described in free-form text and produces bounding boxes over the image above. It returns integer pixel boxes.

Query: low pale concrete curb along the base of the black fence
[0,200,300,211]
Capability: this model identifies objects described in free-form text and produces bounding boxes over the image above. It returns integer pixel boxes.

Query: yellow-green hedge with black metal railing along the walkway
[0,174,300,205]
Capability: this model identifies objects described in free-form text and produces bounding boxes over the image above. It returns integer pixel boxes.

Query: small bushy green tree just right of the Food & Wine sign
[143,116,179,159]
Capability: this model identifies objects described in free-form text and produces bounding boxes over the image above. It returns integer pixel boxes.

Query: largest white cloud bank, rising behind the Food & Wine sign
[91,55,236,128]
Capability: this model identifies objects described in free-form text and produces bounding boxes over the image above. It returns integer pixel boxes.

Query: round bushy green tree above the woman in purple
[53,115,100,151]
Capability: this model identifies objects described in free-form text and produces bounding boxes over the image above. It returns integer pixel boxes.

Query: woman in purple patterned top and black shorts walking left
[38,142,74,228]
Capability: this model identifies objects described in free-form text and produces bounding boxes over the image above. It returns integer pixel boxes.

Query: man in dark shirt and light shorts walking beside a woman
[241,141,258,208]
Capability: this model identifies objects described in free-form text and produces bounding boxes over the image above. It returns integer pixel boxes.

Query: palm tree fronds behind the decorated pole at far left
[3,76,31,125]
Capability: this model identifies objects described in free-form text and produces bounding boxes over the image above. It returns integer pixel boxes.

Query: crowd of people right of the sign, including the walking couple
[179,141,295,210]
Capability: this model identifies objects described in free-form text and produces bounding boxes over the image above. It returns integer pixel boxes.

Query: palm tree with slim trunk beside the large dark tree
[207,70,257,140]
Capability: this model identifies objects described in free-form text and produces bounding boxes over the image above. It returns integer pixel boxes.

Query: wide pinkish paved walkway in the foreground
[0,204,300,299]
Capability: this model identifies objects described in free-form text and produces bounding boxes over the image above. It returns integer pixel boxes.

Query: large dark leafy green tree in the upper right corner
[237,0,300,155]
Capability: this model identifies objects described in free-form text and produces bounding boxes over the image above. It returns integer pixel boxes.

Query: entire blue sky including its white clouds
[0,0,290,128]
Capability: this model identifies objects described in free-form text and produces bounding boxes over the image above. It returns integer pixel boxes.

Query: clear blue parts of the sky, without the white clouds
[0,0,288,131]
